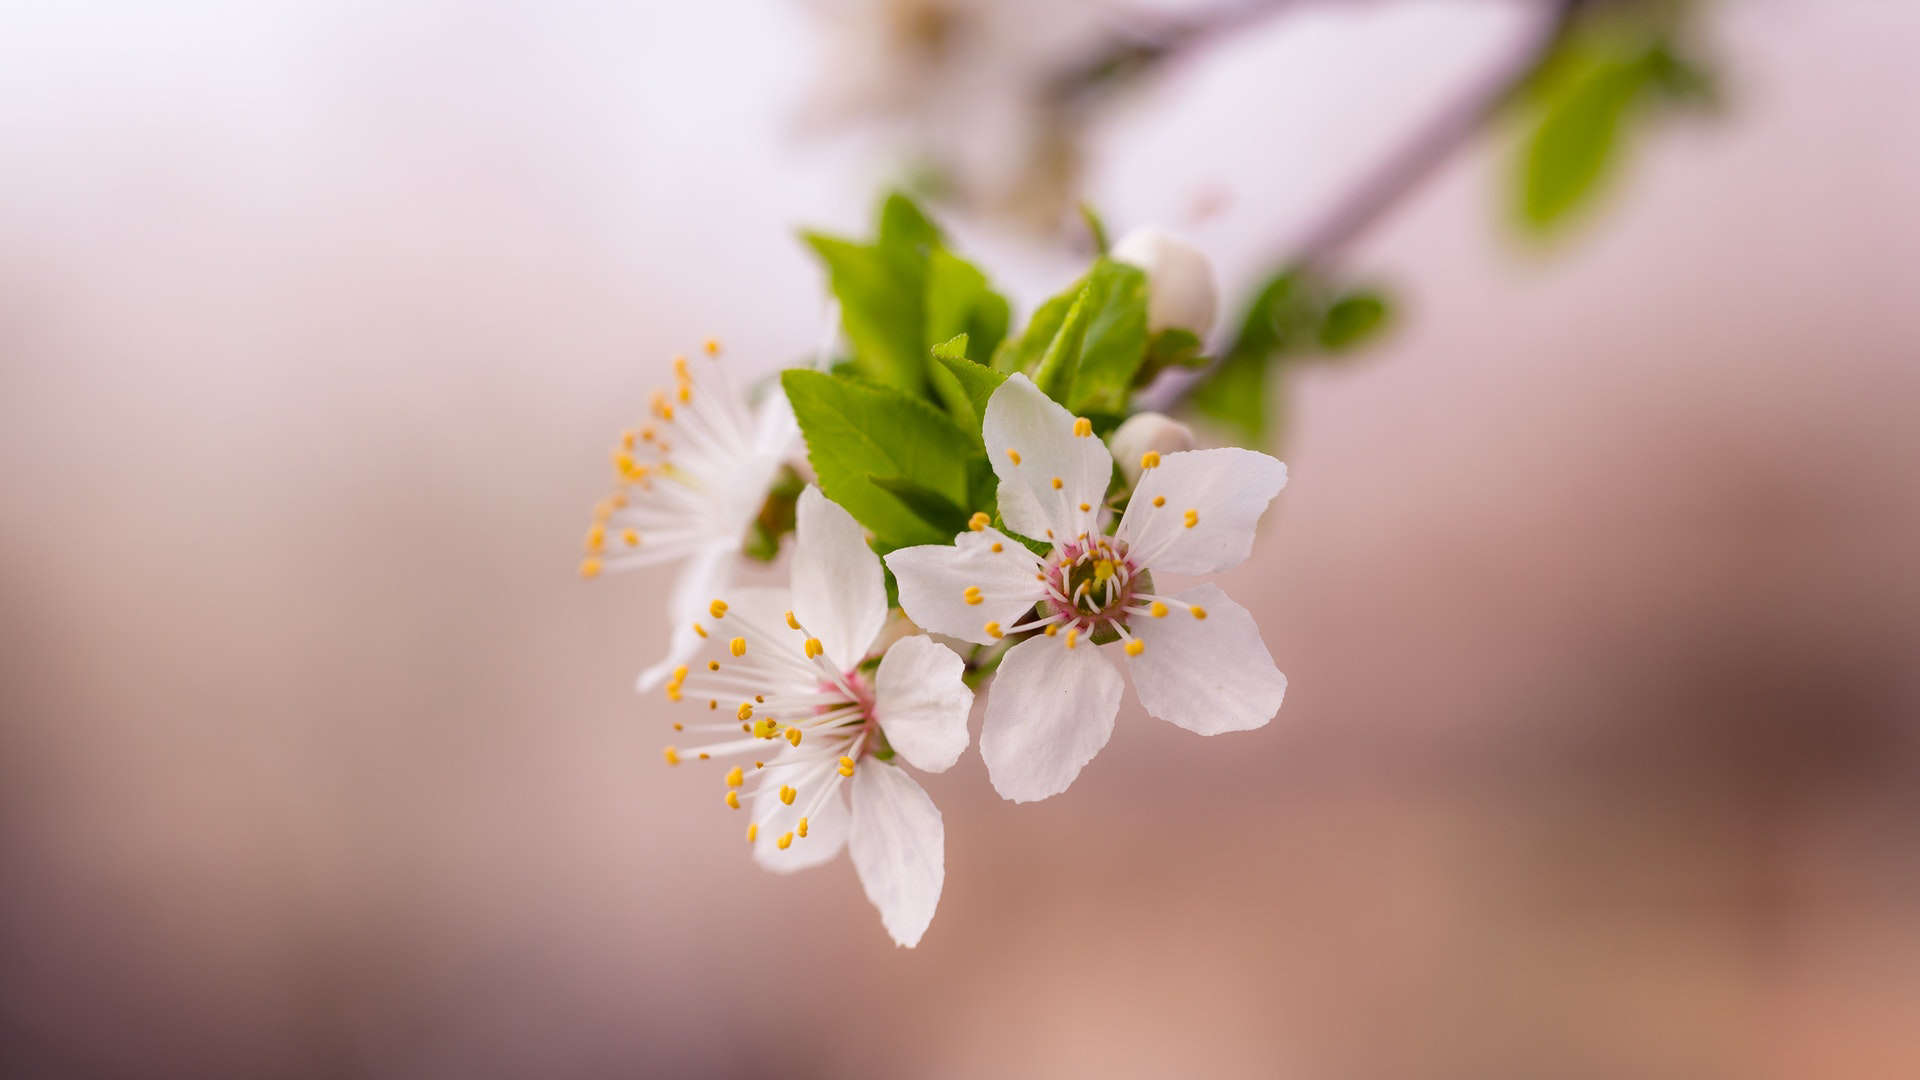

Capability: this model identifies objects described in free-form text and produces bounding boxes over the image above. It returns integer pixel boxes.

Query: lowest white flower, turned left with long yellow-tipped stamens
[666,486,973,945]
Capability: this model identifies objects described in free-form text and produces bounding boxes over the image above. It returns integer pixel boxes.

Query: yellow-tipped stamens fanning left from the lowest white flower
[664,600,885,851]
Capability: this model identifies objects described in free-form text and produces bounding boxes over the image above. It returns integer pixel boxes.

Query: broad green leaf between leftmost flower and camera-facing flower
[780,369,981,550]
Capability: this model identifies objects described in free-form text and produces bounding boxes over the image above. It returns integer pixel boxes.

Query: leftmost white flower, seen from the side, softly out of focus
[580,340,799,690]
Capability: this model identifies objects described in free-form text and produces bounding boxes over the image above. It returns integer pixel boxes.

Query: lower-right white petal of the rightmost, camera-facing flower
[1128,584,1286,734]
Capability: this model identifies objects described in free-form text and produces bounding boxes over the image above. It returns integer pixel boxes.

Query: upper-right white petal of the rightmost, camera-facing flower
[1117,446,1286,575]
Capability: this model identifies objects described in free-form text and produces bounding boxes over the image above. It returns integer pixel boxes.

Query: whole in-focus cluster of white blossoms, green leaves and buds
[580,198,1286,945]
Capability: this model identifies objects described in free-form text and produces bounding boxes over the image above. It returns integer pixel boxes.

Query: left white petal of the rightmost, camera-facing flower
[887,528,1046,646]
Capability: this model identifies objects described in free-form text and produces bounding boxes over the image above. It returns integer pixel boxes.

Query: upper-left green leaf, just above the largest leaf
[804,233,927,394]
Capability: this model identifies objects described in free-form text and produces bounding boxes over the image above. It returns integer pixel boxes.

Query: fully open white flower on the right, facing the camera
[887,375,1286,801]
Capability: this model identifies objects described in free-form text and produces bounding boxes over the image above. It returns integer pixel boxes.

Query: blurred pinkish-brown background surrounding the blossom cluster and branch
[0,0,1920,1080]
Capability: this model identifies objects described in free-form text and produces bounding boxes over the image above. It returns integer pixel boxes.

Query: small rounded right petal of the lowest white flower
[874,634,973,773]
